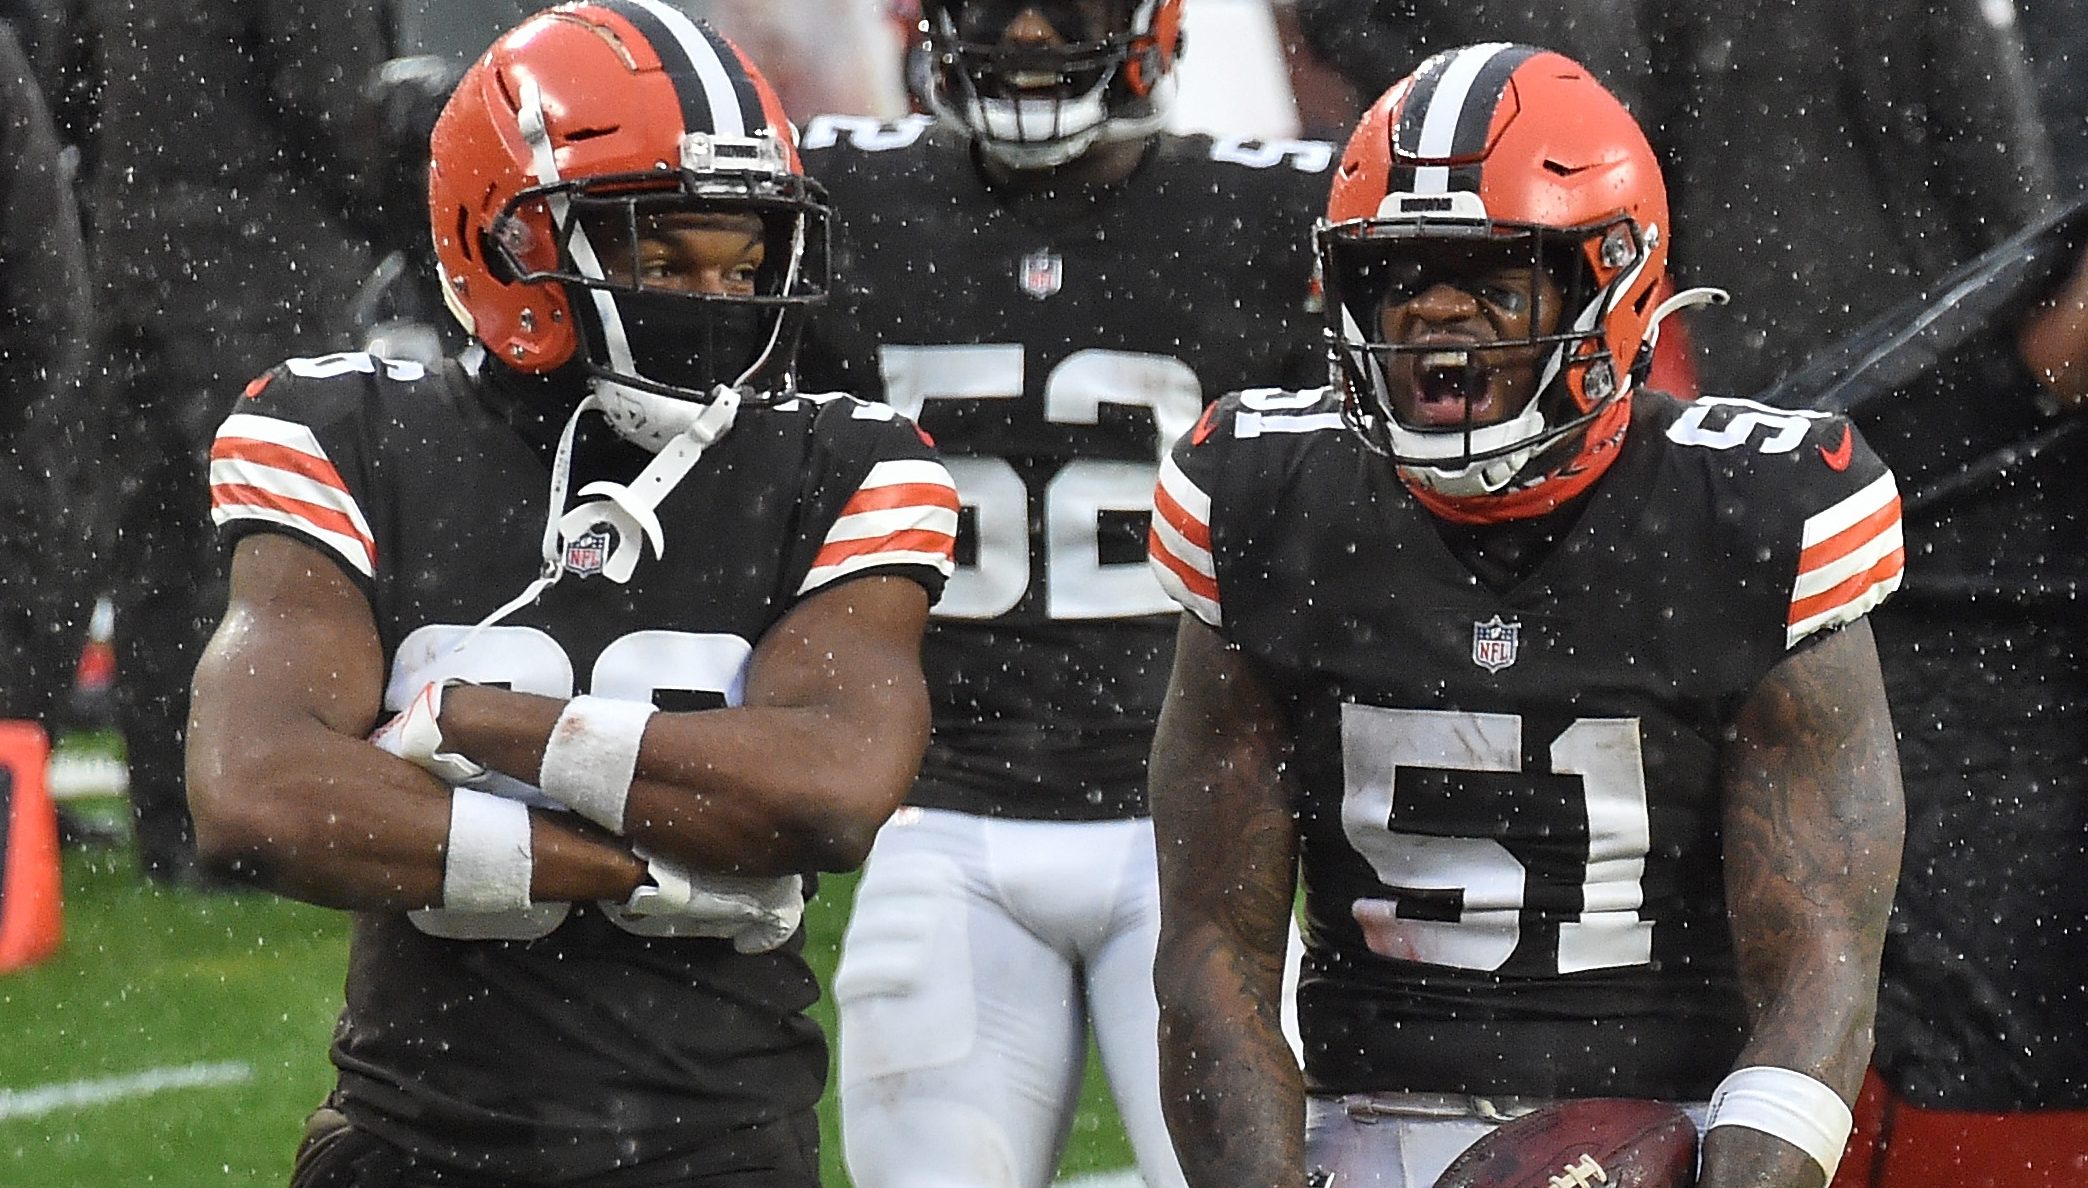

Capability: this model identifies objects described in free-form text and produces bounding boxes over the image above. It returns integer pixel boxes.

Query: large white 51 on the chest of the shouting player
[1340,704,1654,973]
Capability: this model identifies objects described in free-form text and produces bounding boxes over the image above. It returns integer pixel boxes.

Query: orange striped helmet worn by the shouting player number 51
[1315,44,1668,522]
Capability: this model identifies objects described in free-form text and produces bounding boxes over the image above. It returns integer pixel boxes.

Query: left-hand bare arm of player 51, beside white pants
[1153,616,1305,1188]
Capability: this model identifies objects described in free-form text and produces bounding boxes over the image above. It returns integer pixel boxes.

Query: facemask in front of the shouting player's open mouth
[1318,208,1645,497]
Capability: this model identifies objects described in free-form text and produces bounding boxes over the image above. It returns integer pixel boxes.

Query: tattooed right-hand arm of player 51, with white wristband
[1702,620,1906,1188]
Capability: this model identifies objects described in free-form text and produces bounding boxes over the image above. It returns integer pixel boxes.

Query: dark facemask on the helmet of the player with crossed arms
[487,134,829,449]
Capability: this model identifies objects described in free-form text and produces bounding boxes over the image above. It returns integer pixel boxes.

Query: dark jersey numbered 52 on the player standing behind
[802,117,1332,818]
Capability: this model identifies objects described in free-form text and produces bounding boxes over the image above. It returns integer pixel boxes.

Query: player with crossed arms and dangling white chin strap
[190,0,956,1188]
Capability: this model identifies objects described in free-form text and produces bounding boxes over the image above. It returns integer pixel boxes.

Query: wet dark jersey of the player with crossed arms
[211,355,956,1184]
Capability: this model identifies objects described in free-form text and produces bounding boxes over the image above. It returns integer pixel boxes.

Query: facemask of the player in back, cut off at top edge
[923,0,1173,169]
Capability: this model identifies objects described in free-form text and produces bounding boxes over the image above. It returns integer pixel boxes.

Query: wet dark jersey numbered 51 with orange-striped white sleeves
[1153,390,1904,1100]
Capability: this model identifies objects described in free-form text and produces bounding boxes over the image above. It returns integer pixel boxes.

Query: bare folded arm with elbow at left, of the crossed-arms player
[188,532,645,910]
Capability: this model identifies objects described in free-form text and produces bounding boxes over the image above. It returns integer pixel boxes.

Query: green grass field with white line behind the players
[0,800,1132,1188]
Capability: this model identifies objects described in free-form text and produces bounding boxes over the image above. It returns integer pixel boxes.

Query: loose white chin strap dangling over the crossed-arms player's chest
[455,384,739,651]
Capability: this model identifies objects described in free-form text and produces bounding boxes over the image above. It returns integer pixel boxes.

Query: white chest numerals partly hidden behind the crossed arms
[384,622,754,940]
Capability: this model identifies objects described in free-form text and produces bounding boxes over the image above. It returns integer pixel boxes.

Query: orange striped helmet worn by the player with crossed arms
[428,0,829,436]
